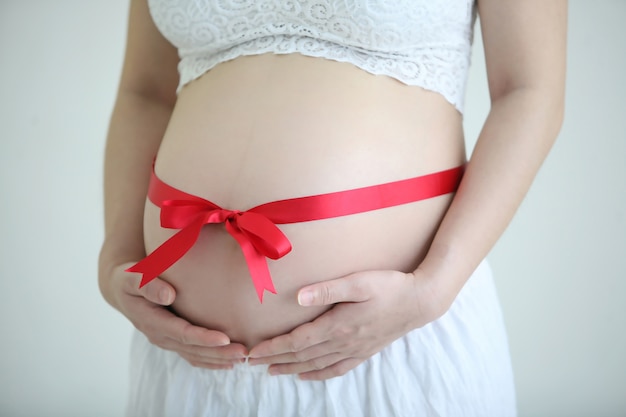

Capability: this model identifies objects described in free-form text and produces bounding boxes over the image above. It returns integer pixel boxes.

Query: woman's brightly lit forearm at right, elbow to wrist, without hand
[419,88,563,309]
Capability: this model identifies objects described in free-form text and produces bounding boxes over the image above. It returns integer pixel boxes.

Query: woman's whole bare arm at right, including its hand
[250,0,567,379]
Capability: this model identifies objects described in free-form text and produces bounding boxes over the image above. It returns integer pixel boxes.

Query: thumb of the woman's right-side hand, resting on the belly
[298,274,371,307]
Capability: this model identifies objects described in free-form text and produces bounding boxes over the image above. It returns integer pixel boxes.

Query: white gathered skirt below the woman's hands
[127,262,516,417]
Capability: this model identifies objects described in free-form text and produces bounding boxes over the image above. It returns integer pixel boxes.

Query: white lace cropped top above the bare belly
[148,0,476,112]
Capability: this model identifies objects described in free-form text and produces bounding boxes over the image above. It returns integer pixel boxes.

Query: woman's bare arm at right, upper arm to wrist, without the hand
[418,0,567,311]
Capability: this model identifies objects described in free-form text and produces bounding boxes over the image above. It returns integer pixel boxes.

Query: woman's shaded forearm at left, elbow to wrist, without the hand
[99,90,172,304]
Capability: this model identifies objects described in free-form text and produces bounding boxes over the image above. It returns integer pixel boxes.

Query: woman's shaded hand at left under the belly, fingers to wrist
[100,263,248,369]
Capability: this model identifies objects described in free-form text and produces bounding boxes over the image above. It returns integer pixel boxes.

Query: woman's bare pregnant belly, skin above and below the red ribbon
[145,54,465,346]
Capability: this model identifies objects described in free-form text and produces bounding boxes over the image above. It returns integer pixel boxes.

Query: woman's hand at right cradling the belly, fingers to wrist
[249,271,438,380]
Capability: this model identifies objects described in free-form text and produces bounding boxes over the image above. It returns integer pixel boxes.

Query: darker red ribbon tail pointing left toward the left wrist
[126,218,204,288]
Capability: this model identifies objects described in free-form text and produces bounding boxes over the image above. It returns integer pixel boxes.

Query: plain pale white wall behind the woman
[0,0,626,417]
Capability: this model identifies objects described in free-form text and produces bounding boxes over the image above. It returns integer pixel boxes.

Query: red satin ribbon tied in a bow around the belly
[127,166,463,302]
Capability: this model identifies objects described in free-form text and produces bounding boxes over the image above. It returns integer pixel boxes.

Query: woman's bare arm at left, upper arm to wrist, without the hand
[100,1,178,292]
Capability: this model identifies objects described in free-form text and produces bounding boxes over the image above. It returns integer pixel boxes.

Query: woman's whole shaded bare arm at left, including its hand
[99,0,247,369]
